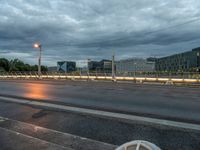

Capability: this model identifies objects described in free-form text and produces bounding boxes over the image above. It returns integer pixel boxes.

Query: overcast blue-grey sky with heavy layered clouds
[0,0,200,66]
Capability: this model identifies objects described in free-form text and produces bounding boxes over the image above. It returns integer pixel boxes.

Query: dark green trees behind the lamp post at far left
[0,58,48,72]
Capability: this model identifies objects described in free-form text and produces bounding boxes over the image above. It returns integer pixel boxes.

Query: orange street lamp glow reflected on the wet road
[24,83,48,99]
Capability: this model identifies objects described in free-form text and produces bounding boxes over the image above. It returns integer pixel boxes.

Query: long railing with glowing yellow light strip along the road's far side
[0,72,200,84]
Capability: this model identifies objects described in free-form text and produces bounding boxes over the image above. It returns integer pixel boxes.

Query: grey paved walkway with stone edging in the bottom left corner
[0,117,116,150]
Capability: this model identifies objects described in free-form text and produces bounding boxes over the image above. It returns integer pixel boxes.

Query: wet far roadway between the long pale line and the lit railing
[0,81,200,123]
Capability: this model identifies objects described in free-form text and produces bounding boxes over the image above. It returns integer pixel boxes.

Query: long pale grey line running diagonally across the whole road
[0,96,200,131]
